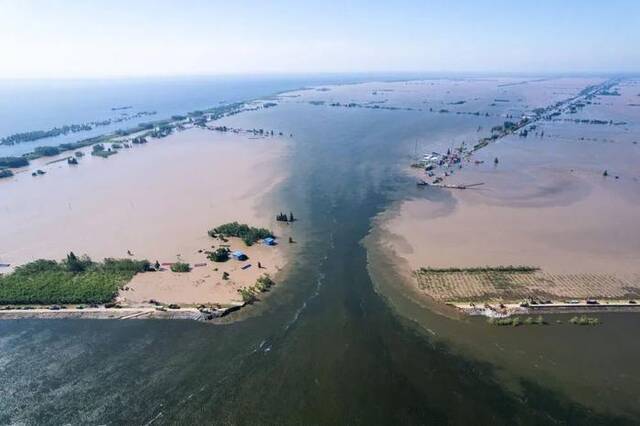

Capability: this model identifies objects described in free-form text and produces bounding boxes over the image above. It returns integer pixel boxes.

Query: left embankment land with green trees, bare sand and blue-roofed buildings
[0,222,280,320]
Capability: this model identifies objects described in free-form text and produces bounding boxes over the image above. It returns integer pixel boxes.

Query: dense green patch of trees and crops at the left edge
[0,252,151,305]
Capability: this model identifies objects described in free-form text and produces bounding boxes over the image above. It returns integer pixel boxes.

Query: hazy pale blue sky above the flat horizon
[0,0,640,78]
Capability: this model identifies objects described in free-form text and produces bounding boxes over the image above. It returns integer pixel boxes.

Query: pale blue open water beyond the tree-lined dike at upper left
[0,74,398,156]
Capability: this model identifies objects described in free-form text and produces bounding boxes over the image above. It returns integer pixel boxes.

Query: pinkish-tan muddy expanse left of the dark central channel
[0,129,290,305]
